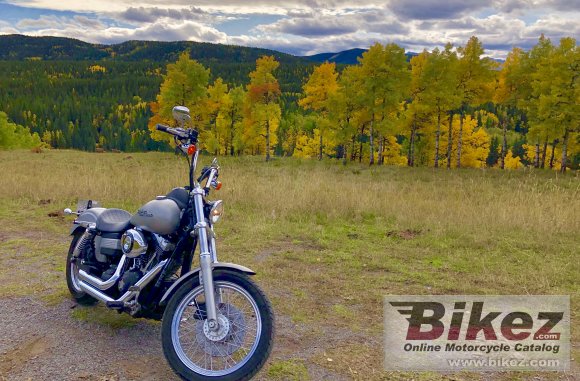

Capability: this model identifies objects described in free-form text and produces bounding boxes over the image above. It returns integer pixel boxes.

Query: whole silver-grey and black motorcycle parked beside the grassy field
[65,106,274,381]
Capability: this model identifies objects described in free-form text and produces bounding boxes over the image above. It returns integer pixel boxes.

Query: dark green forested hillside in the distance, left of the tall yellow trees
[0,35,314,151]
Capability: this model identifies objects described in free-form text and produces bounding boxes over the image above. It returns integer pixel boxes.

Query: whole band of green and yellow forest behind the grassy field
[0,36,580,171]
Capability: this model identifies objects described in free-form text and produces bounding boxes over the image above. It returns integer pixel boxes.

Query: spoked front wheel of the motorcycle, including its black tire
[161,270,274,381]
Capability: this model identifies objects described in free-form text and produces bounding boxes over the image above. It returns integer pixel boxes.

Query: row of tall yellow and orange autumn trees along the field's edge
[150,36,580,171]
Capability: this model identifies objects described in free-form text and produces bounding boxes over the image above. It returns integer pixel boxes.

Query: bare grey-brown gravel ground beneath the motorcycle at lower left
[0,298,179,381]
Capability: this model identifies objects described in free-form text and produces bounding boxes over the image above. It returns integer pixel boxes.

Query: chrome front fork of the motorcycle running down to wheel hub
[192,185,219,330]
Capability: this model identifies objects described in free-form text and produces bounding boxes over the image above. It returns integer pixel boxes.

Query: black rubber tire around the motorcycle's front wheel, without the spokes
[161,270,274,381]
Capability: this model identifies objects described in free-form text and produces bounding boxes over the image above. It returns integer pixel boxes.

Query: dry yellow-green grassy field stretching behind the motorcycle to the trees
[0,151,580,380]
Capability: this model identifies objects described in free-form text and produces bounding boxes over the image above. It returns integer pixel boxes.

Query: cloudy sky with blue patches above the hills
[0,0,580,58]
